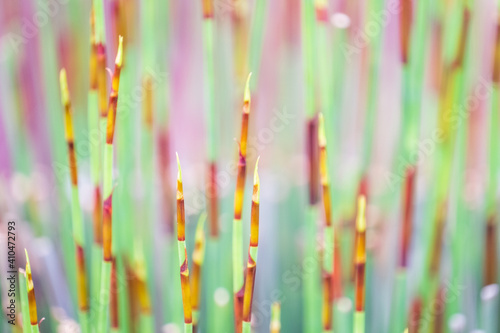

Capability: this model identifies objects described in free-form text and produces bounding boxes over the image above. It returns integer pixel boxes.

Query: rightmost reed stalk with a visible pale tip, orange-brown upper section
[354,196,366,333]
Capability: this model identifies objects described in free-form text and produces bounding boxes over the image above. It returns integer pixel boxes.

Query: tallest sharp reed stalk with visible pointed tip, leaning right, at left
[97,36,123,333]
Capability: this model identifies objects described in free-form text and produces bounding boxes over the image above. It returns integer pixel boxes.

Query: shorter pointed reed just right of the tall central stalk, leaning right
[243,158,260,333]
